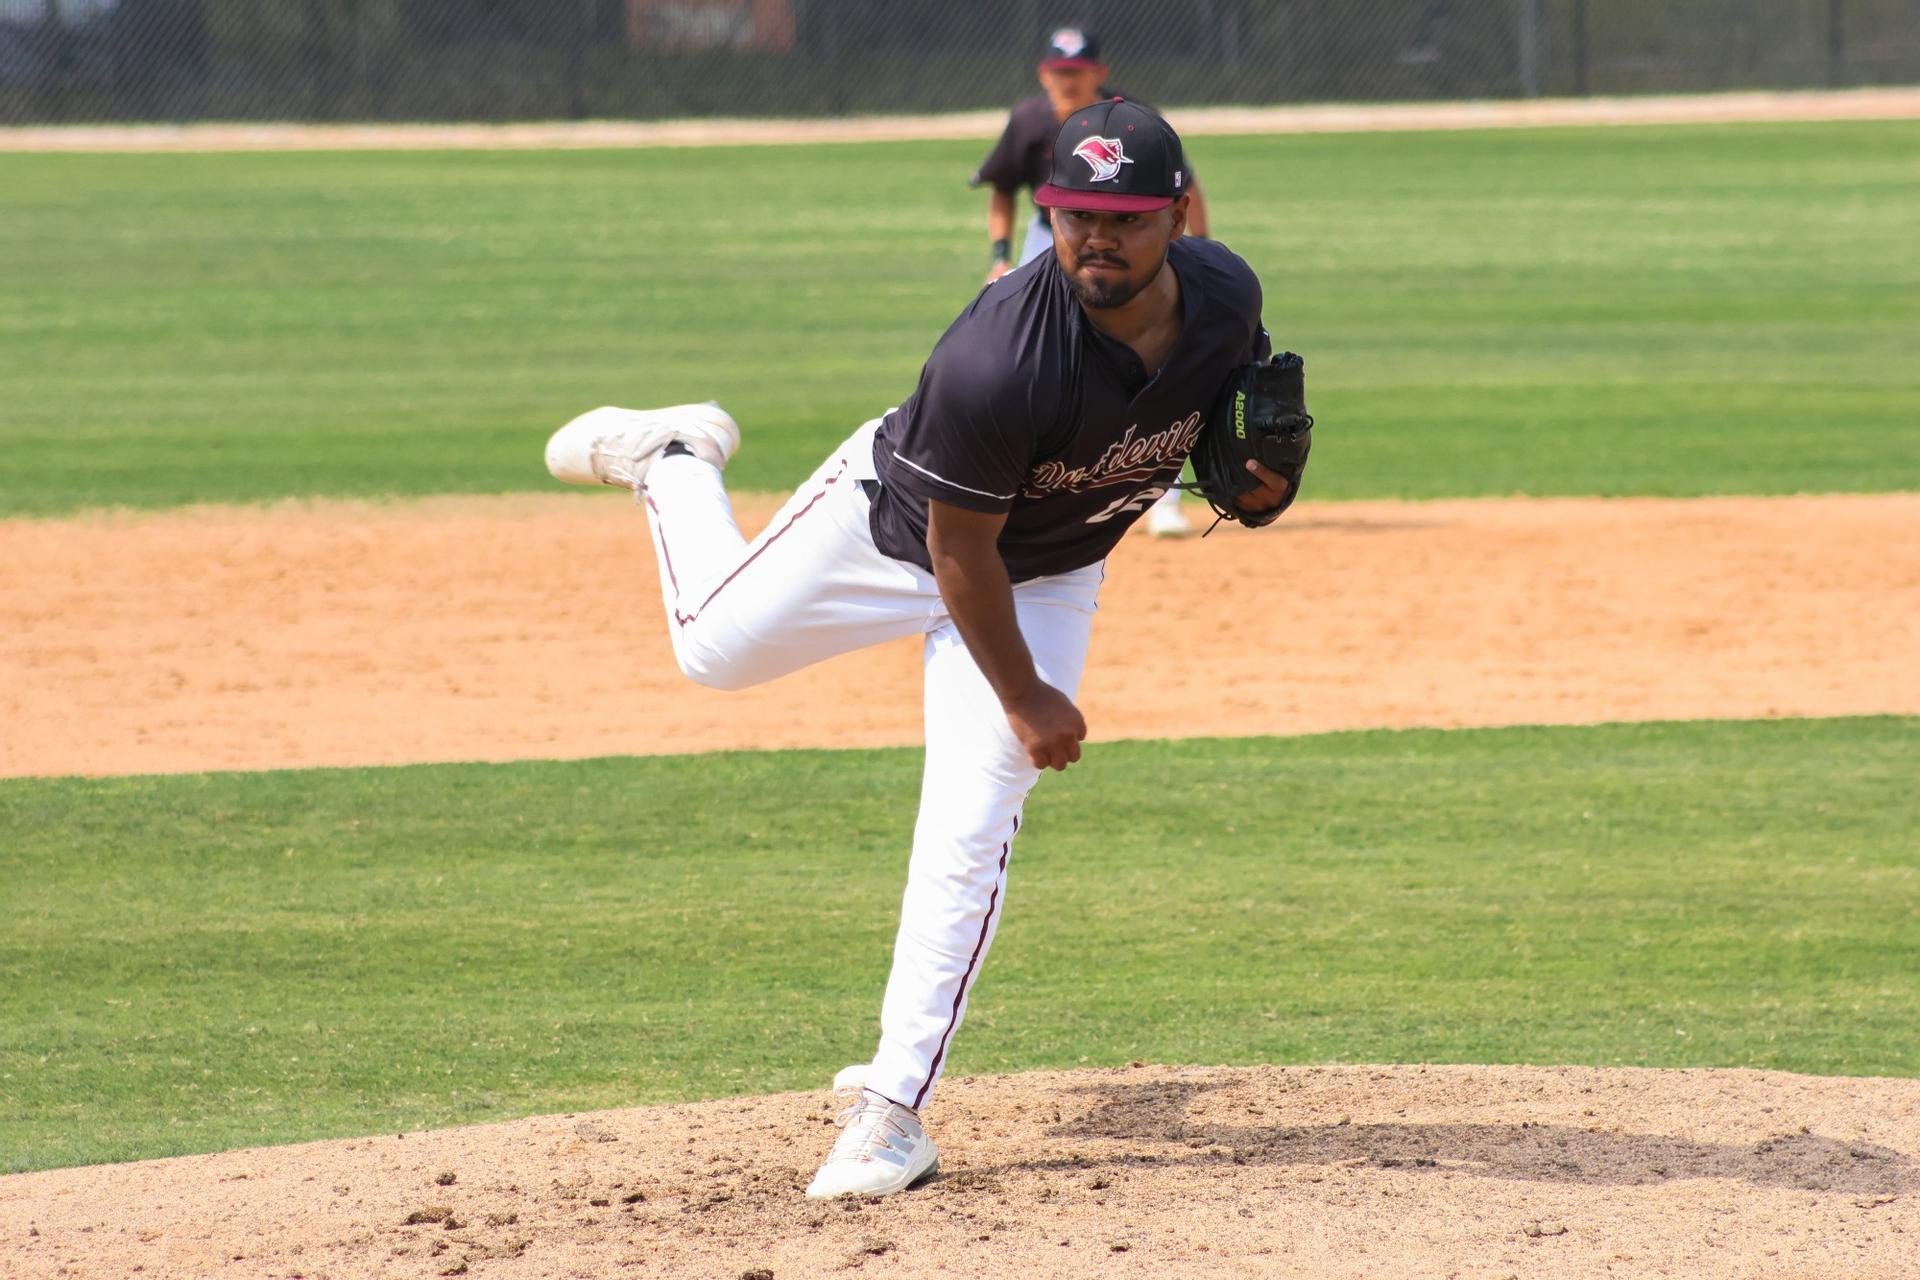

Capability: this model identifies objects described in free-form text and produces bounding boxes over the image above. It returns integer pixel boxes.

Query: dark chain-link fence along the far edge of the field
[0,0,1920,125]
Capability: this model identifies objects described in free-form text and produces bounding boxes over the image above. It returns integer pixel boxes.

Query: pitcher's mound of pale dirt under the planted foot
[0,1067,1920,1280]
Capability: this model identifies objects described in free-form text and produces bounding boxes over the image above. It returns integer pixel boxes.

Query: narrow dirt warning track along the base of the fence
[0,86,1920,152]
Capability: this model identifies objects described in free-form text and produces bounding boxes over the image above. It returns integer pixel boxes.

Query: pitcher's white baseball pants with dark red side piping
[643,422,1104,1107]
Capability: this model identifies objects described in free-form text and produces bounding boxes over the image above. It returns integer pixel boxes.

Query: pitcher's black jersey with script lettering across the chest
[872,238,1269,581]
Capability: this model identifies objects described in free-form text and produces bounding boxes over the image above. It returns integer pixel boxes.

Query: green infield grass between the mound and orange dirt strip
[0,718,1920,1171]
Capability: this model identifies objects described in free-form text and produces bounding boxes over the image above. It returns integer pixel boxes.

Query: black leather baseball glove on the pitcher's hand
[1192,351,1313,530]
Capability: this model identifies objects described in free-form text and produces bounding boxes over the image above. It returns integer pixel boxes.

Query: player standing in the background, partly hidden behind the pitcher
[973,27,1208,537]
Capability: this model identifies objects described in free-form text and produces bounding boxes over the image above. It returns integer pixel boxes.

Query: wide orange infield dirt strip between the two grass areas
[0,493,1920,775]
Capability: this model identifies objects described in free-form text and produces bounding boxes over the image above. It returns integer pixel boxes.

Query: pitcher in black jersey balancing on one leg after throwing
[547,102,1288,1197]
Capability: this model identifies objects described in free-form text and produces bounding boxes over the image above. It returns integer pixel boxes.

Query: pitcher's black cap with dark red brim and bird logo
[1033,98,1188,213]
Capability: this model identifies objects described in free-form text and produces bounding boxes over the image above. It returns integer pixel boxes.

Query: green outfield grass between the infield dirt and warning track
[0,123,1920,514]
